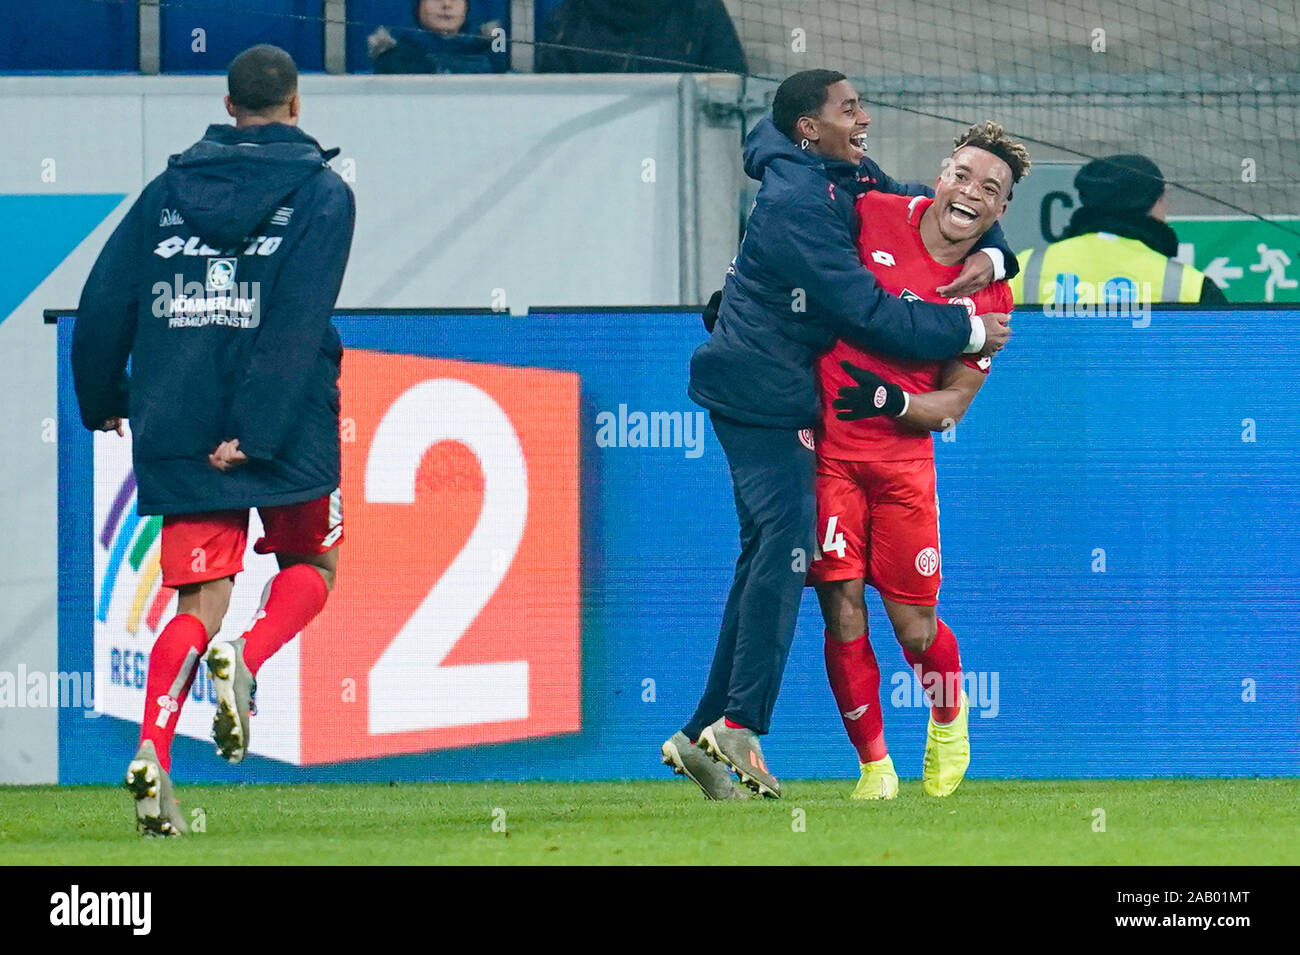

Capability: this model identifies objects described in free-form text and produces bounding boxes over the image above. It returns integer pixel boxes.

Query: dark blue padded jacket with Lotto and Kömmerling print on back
[72,123,356,515]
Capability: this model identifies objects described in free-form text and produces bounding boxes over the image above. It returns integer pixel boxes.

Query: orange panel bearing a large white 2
[302,351,581,763]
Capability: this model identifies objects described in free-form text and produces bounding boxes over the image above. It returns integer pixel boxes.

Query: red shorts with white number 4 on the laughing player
[809,457,943,607]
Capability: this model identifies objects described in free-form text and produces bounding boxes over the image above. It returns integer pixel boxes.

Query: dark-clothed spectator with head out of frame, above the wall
[534,0,745,73]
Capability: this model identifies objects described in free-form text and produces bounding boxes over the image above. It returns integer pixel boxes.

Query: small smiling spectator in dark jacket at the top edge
[367,0,510,73]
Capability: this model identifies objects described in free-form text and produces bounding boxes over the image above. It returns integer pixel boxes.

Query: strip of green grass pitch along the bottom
[0,778,1300,865]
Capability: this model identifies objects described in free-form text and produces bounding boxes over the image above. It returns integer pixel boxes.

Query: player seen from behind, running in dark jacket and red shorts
[72,45,356,835]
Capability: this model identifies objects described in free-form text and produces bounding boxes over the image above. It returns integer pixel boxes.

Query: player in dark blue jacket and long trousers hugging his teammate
[662,70,1015,798]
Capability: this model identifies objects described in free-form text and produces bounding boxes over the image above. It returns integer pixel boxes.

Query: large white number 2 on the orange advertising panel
[365,378,528,733]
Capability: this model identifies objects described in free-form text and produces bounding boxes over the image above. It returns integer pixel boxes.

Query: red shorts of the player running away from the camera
[161,489,343,587]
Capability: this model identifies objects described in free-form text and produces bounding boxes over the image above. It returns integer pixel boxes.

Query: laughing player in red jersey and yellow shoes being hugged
[809,123,1030,799]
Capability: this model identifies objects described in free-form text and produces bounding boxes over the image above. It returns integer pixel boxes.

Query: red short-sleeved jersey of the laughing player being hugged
[816,192,1011,461]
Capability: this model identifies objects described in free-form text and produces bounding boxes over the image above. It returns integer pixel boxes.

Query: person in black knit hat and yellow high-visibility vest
[1011,155,1227,305]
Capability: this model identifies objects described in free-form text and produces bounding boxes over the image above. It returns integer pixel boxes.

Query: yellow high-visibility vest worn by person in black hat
[1010,233,1205,305]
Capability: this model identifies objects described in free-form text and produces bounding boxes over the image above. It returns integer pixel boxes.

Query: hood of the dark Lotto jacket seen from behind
[164,123,338,248]
